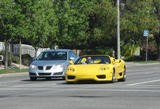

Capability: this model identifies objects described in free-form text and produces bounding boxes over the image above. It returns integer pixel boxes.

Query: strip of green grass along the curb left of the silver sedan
[0,68,28,74]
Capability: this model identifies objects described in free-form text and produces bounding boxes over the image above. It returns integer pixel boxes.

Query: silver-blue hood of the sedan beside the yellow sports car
[31,60,68,66]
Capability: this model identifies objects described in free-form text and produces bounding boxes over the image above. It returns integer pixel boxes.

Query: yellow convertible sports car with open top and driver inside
[65,55,126,83]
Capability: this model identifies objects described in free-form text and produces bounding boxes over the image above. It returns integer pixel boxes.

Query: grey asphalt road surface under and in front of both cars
[0,63,160,109]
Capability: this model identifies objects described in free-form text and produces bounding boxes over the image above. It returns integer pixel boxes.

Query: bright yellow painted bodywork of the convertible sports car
[66,55,125,82]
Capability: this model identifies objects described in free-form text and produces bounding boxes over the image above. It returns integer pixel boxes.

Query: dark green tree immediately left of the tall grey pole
[88,0,117,49]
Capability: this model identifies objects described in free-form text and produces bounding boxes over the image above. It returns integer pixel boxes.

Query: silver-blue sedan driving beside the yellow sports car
[29,49,78,81]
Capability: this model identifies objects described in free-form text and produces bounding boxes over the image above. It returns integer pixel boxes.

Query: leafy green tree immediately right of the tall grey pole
[121,0,155,58]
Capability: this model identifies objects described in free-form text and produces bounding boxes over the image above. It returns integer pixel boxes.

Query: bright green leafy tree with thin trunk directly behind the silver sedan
[16,0,57,56]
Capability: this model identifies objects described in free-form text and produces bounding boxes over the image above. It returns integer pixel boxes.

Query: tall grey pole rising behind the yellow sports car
[117,0,121,59]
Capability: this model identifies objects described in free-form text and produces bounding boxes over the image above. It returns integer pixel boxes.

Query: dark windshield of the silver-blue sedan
[36,51,67,60]
